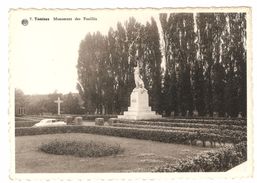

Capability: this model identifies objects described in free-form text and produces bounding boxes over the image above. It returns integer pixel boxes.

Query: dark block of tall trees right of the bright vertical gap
[160,13,246,116]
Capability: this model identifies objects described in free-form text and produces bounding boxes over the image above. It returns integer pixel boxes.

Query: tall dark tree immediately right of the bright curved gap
[160,13,195,115]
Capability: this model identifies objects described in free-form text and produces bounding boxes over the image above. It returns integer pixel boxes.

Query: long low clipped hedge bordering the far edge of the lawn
[15,126,242,146]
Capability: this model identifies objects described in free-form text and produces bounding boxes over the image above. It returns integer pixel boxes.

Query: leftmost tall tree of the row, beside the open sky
[77,32,108,113]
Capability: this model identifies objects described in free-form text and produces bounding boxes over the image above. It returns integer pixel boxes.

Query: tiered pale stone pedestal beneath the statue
[118,88,162,120]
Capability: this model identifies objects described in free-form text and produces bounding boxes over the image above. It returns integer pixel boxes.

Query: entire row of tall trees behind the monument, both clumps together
[77,13,247,117]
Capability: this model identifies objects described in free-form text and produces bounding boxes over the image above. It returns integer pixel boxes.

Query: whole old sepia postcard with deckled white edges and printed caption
[9,7,253,178]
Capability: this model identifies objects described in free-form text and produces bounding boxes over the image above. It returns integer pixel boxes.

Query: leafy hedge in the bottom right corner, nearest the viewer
[153,141,247,172]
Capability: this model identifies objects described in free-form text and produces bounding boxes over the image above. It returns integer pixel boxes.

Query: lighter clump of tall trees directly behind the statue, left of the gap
[77,18,162,114]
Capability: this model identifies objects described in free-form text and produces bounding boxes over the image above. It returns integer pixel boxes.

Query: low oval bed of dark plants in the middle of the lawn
[39,140,124,157]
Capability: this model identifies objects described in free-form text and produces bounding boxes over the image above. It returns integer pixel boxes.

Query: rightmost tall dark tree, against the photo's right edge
[222,13,247,117]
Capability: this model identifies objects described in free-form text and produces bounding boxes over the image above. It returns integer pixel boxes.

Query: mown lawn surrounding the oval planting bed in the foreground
[15,133,210,173]
